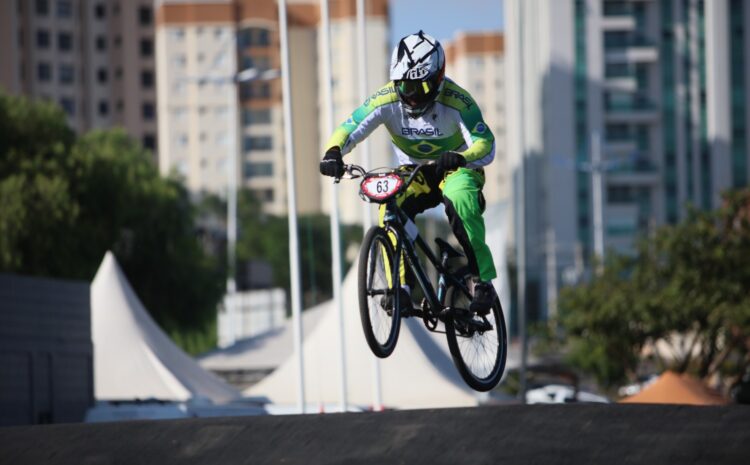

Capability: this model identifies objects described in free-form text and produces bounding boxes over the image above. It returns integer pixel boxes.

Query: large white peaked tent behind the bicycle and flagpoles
[244,263,478,409]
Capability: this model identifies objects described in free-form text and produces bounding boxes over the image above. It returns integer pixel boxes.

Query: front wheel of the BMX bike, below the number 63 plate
[358,226,401,358]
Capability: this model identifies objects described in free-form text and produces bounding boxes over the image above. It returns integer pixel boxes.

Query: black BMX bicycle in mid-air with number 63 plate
[334,164,508,391]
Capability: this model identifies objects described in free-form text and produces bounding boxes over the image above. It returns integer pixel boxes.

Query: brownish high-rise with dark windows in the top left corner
[0,0,157,156]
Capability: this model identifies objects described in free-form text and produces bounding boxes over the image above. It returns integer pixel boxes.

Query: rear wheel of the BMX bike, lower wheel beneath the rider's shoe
[445,276,508,392]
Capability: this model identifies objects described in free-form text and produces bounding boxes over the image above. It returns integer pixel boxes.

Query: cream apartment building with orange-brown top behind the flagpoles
[156,0,388,218]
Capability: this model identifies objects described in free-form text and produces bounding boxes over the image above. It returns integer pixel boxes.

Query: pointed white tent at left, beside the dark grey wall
[91,252,239,403]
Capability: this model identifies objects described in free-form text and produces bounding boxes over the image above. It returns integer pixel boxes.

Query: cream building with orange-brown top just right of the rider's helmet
[445,32,510,204]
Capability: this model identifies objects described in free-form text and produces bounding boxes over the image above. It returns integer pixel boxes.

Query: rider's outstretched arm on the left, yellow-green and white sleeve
[326,82,398,154]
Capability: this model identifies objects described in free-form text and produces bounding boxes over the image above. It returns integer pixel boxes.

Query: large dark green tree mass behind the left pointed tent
[0,95,224,351]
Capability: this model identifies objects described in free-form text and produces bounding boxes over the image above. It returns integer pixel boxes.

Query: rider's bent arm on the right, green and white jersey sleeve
[438,81,495,168]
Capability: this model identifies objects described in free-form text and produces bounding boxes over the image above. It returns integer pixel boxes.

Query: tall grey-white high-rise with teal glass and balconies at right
[505,0,750,320]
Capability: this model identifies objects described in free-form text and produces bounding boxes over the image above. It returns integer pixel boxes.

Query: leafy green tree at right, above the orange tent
[560,189,750,386]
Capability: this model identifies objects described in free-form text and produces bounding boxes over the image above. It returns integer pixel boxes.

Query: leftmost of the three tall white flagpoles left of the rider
[279,0,305,413]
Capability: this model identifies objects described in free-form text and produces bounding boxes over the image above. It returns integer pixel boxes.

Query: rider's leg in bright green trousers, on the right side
[440,168,497,282]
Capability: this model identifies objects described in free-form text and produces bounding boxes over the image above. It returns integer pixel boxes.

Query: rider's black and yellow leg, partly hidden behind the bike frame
[378,166,443,288]
